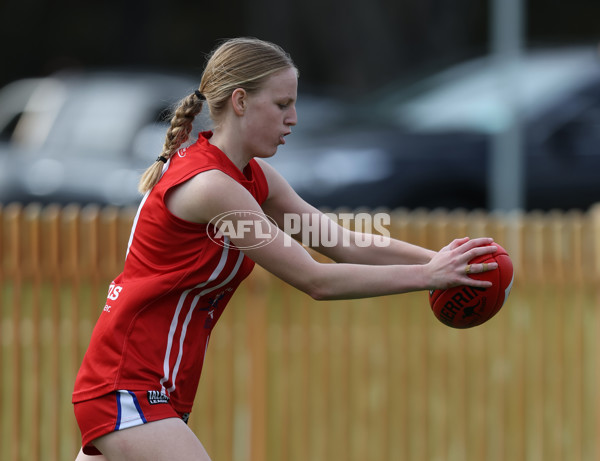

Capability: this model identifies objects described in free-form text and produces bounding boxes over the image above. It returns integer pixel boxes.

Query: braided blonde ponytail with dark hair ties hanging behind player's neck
[138,90,205,194]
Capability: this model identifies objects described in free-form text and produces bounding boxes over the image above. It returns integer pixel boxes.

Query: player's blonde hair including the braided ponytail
[138,38,297,194]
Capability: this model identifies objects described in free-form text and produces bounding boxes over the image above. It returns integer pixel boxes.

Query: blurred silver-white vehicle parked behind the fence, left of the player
[0,71,202,205]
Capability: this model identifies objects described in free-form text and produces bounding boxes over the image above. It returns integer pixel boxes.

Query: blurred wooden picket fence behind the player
[0,205,600,461]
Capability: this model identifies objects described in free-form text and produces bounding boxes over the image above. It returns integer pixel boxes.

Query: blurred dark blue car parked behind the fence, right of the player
[271,47,600,210]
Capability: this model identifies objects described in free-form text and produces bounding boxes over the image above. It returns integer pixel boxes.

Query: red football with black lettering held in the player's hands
[429,243,513,328]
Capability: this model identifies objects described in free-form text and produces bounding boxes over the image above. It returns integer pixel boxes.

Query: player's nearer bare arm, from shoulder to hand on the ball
[168,170,495,299]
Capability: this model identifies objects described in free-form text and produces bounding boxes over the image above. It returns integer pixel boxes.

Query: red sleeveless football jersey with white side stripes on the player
[73,132,268,412]
